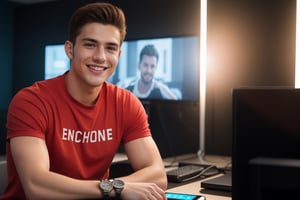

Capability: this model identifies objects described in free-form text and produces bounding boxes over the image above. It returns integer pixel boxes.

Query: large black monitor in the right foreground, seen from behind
[232,87,300,200]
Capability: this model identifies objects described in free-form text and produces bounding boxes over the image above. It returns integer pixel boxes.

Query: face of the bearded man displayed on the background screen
[139,55,157,84]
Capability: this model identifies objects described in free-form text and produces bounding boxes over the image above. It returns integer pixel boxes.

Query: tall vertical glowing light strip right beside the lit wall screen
[198,0,207,156]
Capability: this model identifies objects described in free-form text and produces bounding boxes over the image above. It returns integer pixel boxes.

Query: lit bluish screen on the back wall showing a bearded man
[45,36,199,101]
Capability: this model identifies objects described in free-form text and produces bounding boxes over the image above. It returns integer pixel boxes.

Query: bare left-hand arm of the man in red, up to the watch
[10,136,102,199]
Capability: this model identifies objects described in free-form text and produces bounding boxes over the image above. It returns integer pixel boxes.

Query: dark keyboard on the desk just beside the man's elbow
[167,165,205,183]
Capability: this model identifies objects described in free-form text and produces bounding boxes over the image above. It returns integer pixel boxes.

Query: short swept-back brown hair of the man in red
[68,2,126,44]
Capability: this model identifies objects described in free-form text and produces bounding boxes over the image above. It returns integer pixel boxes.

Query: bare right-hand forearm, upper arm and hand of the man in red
[116,137,167,199]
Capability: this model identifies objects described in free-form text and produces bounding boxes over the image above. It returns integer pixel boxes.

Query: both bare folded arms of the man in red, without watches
[10,136,167,199]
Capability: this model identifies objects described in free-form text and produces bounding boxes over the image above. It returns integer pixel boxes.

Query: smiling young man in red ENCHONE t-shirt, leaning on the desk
[2,3,167,200]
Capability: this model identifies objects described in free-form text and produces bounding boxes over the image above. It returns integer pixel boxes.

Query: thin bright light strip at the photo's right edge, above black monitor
[295,0,300,88]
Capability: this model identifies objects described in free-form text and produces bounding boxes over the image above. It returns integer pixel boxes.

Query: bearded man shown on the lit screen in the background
[126,44,177,99]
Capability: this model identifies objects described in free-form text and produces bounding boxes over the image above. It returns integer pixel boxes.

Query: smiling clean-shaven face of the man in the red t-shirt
[65,23,120,87]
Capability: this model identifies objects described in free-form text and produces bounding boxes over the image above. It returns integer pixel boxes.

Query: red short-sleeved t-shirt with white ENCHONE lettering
[3,75,151,198]
